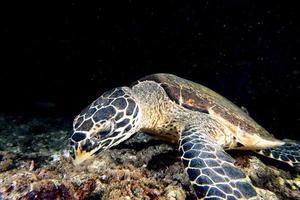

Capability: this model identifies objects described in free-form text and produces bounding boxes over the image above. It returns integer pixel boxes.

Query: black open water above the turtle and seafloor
[0,0,300,140]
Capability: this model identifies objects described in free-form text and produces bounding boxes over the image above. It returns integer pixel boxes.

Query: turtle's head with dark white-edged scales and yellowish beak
[70,87,139,164]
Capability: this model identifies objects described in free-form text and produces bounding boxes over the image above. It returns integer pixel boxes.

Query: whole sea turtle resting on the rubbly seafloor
[70,73,300,200]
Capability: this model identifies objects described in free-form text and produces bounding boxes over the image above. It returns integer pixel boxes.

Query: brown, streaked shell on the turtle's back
[139,74,274,140]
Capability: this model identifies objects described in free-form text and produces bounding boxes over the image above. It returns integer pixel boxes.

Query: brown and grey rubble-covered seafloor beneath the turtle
[0,115,300,200]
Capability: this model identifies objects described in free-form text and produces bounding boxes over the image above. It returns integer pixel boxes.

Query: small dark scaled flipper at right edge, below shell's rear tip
[256,141,300,167]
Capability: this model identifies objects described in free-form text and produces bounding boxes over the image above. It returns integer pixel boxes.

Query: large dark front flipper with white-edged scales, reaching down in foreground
[179,126,258,200]
